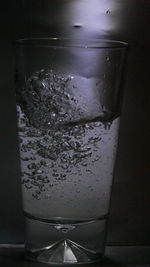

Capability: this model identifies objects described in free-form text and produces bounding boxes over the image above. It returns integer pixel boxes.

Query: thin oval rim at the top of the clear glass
[14,37,128,49]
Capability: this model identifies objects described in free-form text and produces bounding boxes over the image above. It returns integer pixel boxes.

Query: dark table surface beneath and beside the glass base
[0,244,150,267]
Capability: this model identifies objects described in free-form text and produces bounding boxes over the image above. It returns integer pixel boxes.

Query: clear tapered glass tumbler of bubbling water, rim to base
[16,38,127,265]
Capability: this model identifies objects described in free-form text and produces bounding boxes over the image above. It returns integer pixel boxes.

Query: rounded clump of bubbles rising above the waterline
[17,69,79,131]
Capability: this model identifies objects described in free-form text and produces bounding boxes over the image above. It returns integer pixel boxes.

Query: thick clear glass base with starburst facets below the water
[25,217,106,264]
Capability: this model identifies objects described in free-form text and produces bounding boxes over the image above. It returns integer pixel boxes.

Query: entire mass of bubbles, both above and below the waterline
[17,70,113,200]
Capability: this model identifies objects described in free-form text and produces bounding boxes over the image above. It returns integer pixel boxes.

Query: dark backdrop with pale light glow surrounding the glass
[0,0,150,245]
